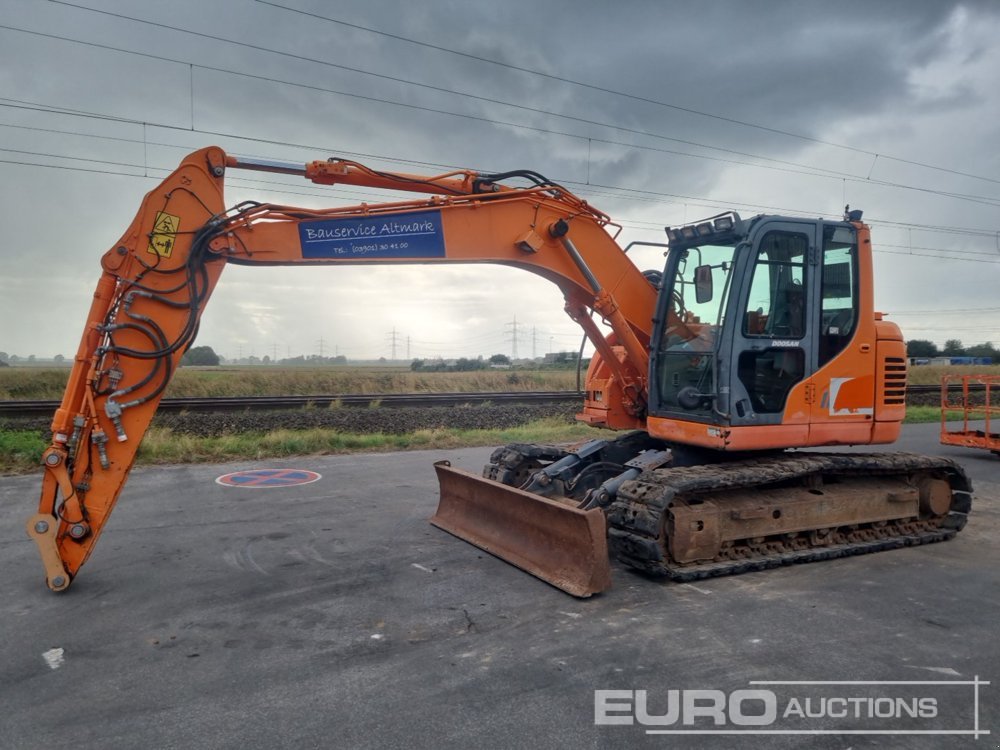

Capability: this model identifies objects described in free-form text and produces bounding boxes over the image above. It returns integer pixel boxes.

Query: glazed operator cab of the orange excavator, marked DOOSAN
[649,213,889,450]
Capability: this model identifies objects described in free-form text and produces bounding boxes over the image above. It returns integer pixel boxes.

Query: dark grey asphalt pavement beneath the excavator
[0,425,1000,750]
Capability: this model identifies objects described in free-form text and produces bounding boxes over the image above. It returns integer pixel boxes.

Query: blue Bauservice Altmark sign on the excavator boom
[299,211,444,260]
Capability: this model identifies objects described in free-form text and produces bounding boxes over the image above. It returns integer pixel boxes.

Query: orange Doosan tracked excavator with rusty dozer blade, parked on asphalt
[27,147,972,597]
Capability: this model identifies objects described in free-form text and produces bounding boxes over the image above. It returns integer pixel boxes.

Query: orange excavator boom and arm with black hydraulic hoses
[28,148,656,590]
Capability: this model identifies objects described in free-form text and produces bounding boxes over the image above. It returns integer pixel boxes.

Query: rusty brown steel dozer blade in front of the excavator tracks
[431,461,611,597]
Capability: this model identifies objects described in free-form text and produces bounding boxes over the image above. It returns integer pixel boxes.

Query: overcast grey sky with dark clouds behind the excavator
[0,0,1000,359]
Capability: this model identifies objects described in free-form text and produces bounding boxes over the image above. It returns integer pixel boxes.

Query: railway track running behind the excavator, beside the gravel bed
[0,391,583,418]
